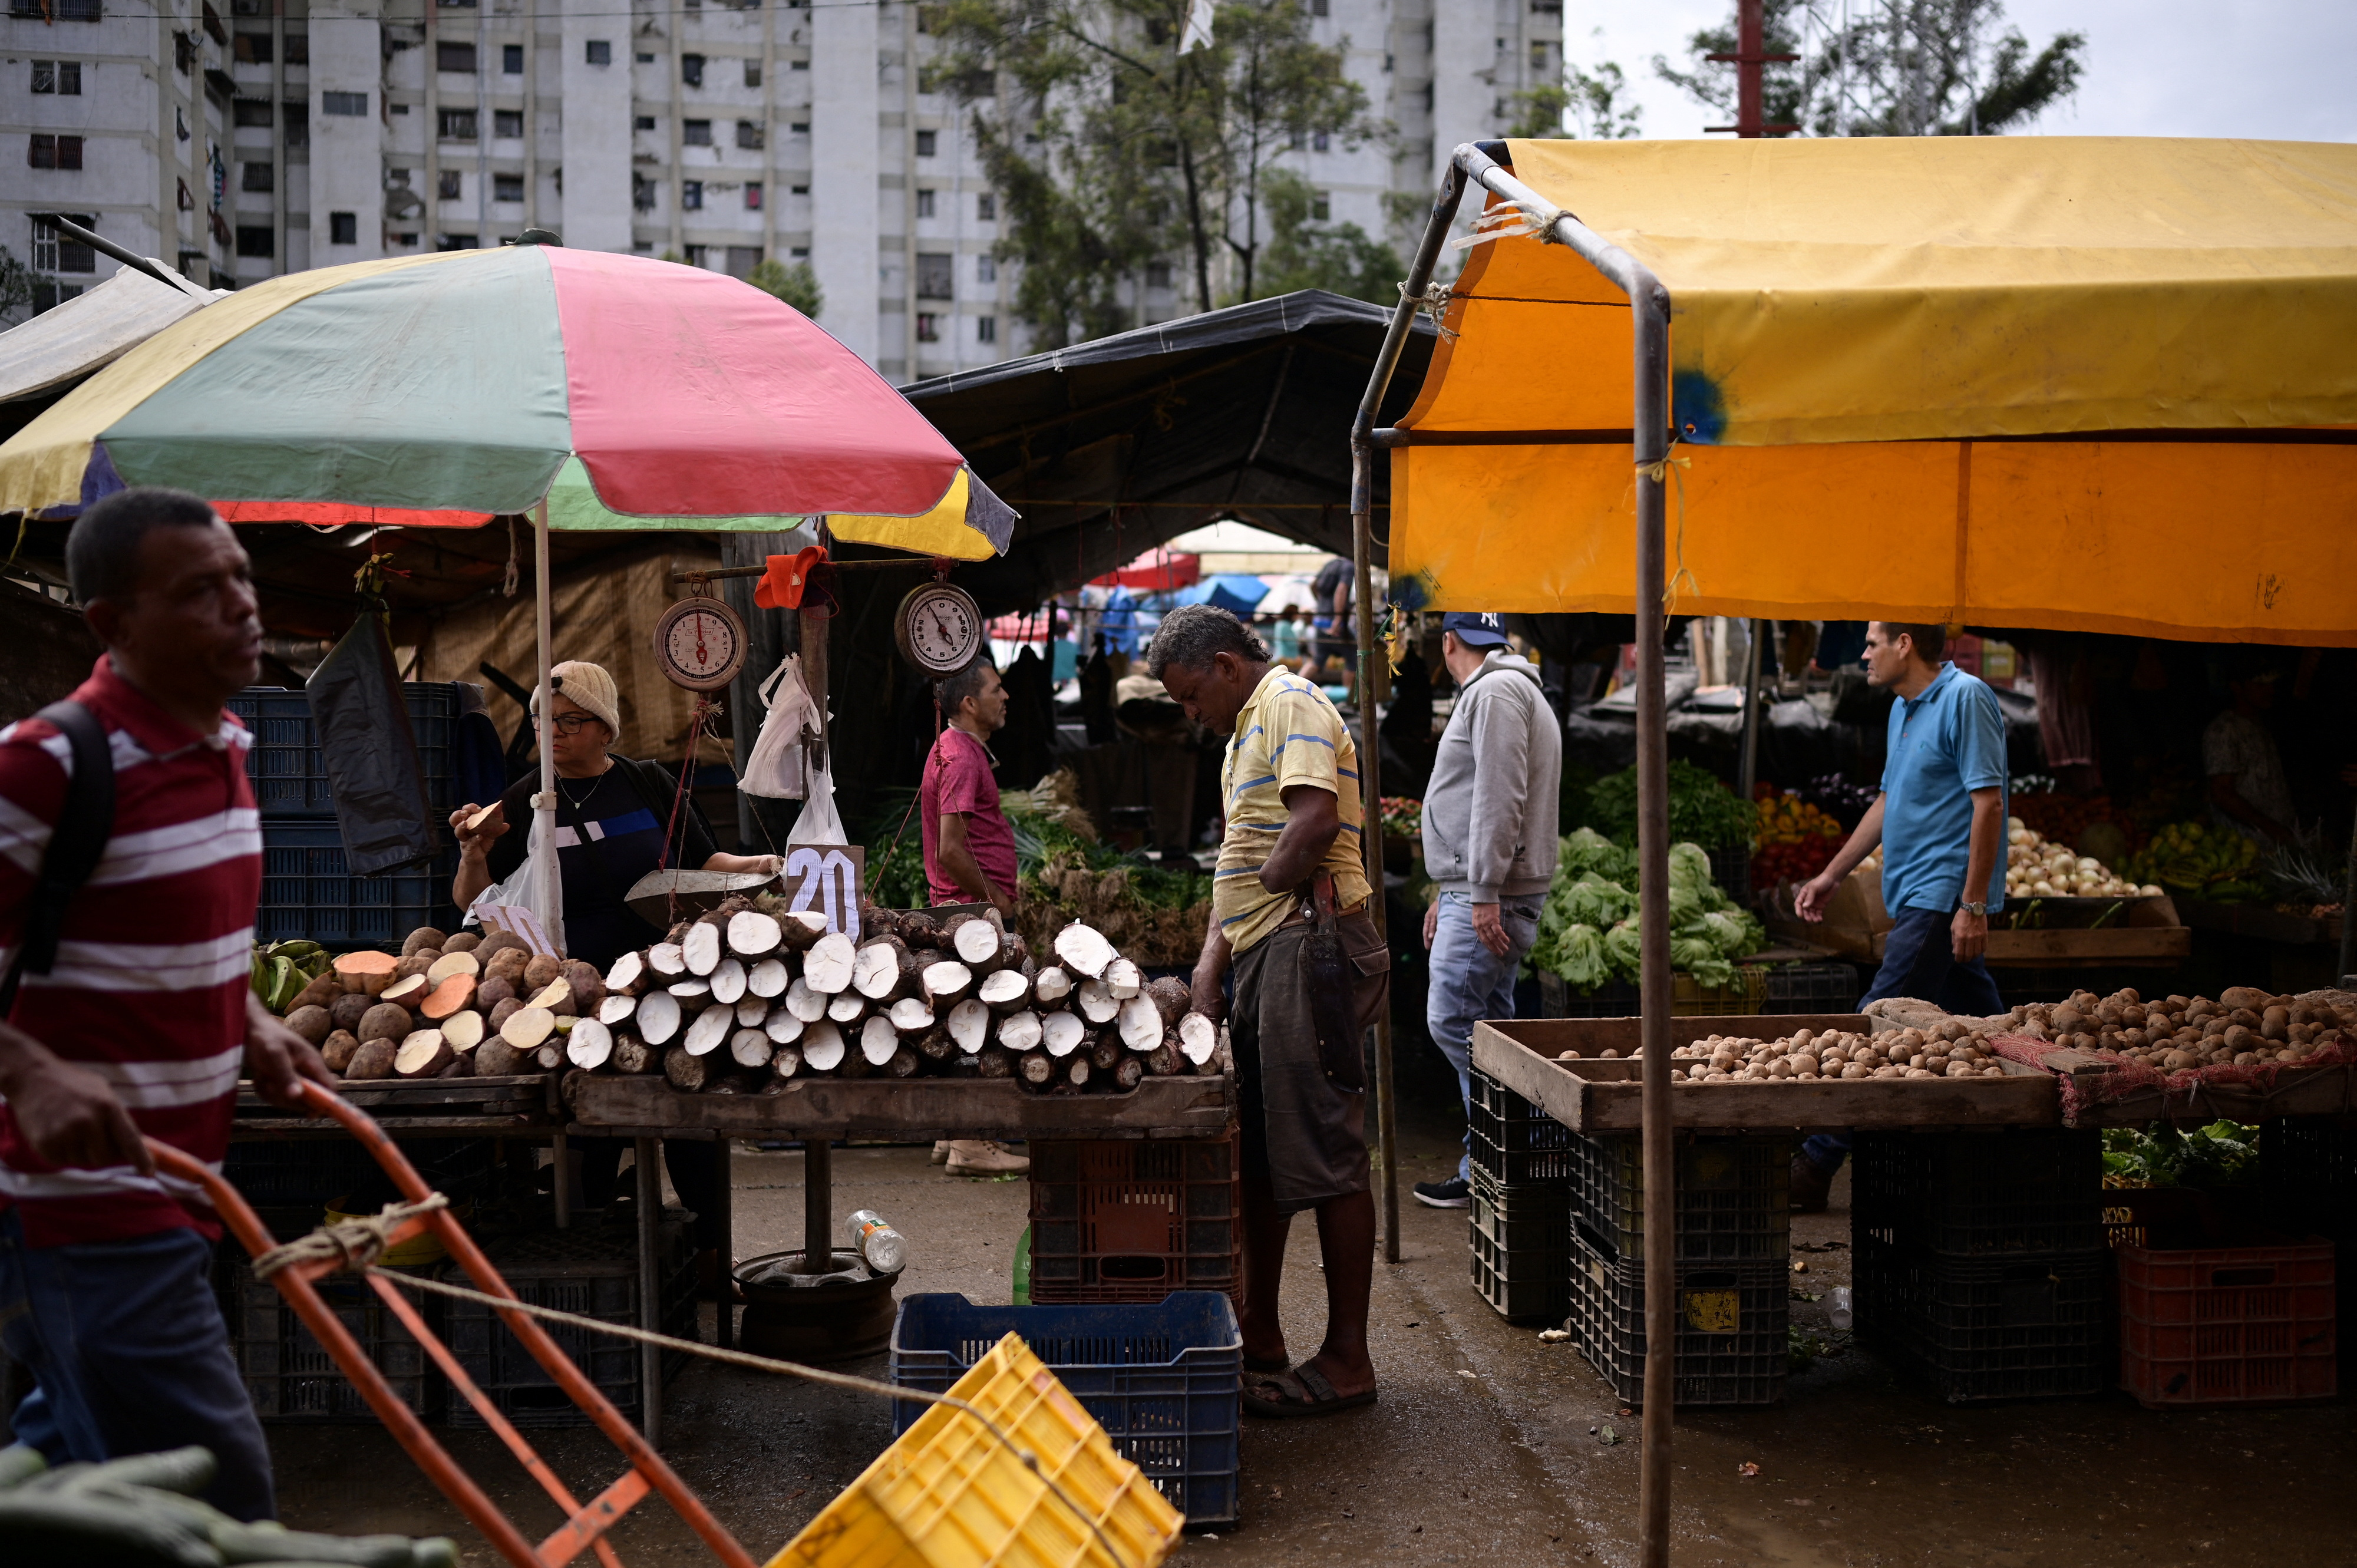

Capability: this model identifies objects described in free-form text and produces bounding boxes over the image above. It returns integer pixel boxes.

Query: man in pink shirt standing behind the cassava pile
[917,655,1030,1177]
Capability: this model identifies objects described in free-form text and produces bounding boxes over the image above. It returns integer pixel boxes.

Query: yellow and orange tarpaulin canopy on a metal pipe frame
[1393,137,2357,643]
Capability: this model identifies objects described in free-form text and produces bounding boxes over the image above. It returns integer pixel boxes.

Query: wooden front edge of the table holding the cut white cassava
[563,1073,1235,1141]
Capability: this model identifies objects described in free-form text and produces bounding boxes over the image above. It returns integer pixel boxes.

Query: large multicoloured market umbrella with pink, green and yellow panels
[0,245,1014,561]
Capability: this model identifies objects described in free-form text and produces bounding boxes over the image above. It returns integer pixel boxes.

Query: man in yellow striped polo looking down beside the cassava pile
[1146,603,1391,1417]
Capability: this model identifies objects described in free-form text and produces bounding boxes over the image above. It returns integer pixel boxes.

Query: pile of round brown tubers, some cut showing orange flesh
[270,927,606,1080]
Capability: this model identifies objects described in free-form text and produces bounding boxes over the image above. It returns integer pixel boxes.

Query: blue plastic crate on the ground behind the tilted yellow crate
[891,1290,1244,1528]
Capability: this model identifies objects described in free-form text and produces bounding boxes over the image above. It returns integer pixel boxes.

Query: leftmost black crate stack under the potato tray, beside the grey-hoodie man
[1466,1068,1572,1325]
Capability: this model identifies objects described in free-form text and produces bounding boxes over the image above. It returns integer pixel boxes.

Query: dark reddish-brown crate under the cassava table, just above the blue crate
[1030,1137,1244,1304]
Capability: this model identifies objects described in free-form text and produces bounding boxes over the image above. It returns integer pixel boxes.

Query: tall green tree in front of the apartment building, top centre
[926,0,1381,346]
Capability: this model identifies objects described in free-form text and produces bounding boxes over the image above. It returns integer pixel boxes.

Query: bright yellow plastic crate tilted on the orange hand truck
[768,1335,1186,1568]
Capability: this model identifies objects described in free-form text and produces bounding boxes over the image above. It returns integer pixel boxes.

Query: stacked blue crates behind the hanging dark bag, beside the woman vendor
[229,681,464,950]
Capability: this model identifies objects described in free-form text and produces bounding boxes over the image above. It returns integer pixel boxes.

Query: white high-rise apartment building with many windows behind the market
[14,0,1563,382]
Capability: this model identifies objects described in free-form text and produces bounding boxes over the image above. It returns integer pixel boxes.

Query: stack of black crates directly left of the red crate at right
[1850,1127,2112,1403]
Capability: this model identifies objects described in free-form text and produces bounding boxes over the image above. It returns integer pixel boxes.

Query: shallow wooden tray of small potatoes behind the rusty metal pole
[1473,1014,2062,1134]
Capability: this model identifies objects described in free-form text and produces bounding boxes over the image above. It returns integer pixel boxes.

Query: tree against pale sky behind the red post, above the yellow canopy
[1652,0,2086,137]
